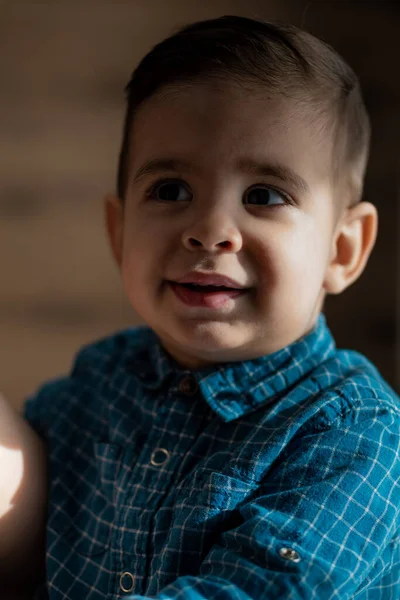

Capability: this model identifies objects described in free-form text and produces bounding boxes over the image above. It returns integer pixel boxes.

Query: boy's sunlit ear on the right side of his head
[323,202,378,294]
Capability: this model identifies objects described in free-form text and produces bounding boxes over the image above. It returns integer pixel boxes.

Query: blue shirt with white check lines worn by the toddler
[25,313,400,600]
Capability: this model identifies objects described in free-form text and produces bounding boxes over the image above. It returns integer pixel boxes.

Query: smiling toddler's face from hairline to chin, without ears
[107,83,344,369]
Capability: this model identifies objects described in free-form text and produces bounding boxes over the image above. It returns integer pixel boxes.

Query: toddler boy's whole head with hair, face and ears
[106,16,377,368]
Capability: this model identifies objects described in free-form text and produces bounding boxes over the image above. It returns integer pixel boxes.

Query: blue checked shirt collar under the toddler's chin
[125,313,336,422]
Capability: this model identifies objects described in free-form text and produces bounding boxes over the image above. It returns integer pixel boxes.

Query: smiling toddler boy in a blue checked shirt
[7,16,400,600]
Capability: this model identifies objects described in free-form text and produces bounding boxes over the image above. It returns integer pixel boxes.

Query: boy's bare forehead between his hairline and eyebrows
[131,83,325,155]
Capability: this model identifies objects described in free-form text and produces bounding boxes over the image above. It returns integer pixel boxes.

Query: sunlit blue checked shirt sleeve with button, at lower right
[126,400,400,600]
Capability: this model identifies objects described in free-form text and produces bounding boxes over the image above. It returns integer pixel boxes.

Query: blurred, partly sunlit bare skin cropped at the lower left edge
[0,394,47,593]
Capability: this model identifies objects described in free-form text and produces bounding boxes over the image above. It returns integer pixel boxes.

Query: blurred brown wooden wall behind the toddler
[0,0,400,408]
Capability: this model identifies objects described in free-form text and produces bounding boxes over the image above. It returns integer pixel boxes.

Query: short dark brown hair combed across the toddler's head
[117,16,370,205]
